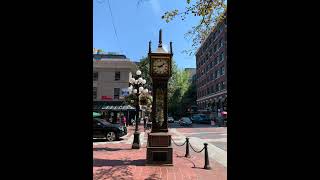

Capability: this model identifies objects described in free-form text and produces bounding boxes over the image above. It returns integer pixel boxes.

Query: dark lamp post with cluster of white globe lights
[128,70,148,149]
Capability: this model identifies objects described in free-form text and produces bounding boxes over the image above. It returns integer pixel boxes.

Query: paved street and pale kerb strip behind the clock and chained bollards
[93,122,227,167]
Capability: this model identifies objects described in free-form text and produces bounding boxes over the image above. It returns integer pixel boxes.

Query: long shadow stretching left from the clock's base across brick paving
[93,159,146,167]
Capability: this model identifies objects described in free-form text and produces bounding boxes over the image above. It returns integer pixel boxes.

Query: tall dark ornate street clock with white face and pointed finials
[147,29,173,165]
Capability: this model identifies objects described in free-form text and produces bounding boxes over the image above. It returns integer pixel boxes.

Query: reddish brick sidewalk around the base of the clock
[93,127,227,180]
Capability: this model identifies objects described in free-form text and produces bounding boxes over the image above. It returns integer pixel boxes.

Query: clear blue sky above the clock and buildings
[93,0,198,68]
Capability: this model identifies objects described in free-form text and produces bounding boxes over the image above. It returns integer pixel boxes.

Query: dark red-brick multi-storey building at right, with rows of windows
[196,14,227,115]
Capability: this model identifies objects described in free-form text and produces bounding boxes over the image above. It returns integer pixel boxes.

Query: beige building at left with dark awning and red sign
[92,54,137,121]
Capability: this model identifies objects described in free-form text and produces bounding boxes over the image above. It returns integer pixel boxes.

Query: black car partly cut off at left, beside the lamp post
[93,118,127,141]
